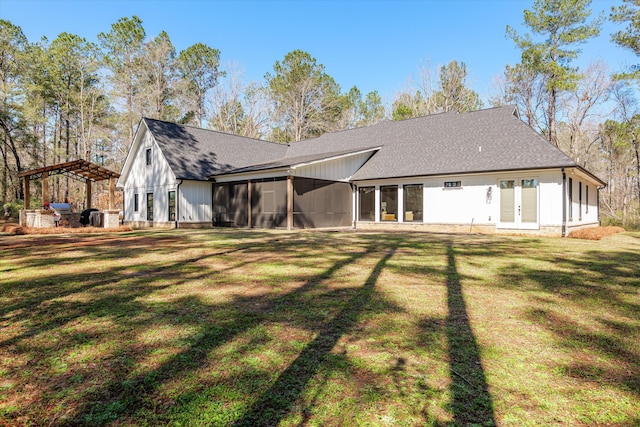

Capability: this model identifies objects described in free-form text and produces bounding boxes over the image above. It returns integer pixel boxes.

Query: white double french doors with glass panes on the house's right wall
[497,177,540,230]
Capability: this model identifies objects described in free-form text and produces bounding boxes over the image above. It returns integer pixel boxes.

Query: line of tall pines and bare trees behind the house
[0,0,640,224]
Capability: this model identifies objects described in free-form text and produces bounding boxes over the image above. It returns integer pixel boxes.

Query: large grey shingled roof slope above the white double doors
[300,106,578,180]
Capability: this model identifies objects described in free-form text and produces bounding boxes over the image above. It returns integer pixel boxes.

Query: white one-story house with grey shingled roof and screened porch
[117,106,605,236]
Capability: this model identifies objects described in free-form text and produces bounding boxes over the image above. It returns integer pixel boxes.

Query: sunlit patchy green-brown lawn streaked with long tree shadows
[0,230,640,426]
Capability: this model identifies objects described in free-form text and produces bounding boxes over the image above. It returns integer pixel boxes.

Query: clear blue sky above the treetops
[0,0,637,103]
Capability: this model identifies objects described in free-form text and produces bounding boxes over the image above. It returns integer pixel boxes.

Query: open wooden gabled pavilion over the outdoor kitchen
[18,159,120,210]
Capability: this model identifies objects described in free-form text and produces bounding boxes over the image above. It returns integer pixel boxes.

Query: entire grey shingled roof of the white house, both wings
[143,106,592,180]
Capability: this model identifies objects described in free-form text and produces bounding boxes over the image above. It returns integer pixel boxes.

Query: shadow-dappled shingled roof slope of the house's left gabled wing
[142,118,287,181]
